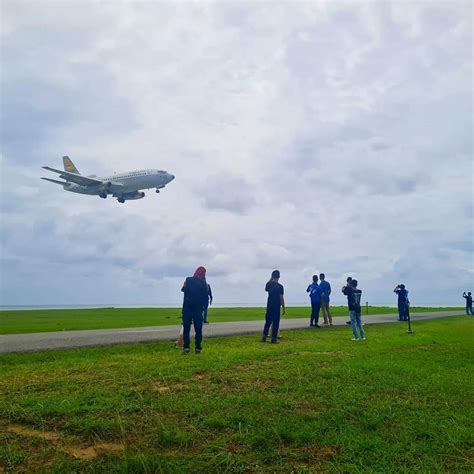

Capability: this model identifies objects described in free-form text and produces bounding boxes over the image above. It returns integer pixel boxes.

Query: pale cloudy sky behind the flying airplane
[0,0,474,305]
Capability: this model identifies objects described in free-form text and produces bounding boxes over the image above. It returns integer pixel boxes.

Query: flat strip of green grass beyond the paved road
[0,306,463,334]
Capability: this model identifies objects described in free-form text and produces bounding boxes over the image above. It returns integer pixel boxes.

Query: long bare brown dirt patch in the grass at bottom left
[6,425,124,460]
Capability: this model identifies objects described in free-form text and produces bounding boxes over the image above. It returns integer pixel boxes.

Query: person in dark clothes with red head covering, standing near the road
[181,267,208,354]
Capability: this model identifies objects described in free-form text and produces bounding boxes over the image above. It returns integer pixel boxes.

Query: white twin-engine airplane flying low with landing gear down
[41,156,174,203]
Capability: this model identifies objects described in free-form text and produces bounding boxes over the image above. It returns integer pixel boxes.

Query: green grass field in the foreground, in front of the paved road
[0,317,474,473]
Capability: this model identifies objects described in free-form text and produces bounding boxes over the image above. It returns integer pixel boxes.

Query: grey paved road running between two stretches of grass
[0,311,464,353]
